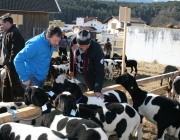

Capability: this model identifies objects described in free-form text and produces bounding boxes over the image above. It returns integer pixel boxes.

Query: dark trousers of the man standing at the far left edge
[1,64,24,102]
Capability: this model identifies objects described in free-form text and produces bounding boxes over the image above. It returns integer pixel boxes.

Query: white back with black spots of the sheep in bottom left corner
[0,122,68,140]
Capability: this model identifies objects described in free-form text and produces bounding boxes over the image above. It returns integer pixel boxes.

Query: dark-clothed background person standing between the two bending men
[59,32,68,56]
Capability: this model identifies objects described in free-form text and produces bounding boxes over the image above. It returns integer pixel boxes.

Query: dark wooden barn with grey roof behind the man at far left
[0,0,61,40]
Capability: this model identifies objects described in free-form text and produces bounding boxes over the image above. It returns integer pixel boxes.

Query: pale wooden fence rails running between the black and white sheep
[0,71,180,124]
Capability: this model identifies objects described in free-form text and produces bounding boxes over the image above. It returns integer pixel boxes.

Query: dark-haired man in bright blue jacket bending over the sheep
[14,26,62,89]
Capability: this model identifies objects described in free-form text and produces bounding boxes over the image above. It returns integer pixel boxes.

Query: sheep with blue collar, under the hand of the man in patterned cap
[62,80,128,104]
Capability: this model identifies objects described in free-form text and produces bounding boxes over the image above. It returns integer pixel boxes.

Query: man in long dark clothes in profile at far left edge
[0,14,25,102]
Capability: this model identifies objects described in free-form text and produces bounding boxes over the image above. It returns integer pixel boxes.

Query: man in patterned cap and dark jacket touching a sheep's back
[69,30,105,98]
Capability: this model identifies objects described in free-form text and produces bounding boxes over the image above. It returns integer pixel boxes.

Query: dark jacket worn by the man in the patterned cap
[70,38,105,92]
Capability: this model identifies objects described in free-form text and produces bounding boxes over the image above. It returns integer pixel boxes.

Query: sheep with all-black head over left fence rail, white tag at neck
[25,87,108,140]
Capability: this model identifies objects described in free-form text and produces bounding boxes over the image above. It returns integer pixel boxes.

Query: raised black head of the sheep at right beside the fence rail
[116,73,138,90]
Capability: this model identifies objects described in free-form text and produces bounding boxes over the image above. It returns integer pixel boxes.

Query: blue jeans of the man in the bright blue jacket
[21,75,45,91]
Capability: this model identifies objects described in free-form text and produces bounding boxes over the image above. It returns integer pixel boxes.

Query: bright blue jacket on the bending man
[14,32,54,82]
